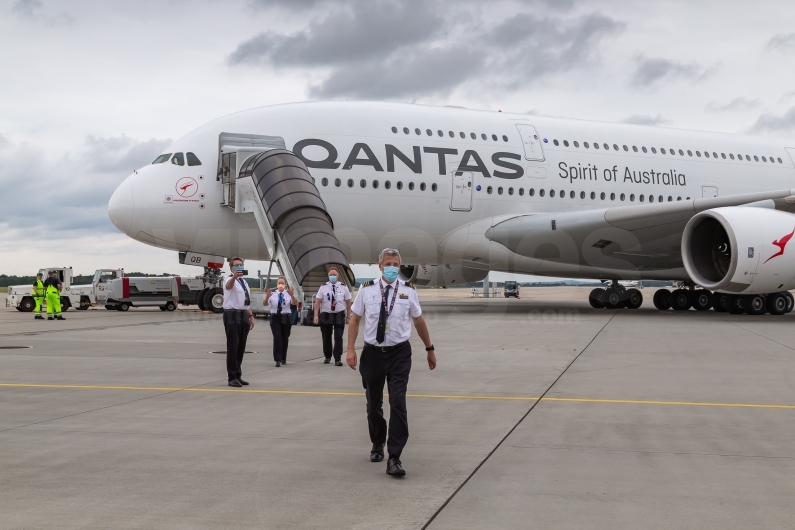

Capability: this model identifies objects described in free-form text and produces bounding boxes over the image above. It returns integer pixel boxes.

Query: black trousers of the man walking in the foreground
[359,341,411,458]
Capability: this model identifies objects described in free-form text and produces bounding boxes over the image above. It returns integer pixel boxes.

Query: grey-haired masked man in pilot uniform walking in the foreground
[346,248,436,477]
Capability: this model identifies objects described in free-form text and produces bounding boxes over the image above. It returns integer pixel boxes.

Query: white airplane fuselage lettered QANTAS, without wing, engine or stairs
[109,102,795,276]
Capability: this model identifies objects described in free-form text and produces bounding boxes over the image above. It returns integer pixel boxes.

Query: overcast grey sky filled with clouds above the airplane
[0,0,795,279]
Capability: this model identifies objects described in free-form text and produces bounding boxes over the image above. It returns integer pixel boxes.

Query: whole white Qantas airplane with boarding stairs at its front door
[108,101,795,314]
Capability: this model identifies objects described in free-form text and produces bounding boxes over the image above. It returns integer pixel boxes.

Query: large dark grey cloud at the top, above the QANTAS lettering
[227,0,624,99]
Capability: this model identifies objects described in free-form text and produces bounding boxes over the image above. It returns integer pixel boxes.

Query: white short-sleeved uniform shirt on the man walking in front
[351,278,422,346]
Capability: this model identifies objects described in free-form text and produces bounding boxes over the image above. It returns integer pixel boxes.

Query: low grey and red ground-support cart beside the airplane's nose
[105,276,180,311]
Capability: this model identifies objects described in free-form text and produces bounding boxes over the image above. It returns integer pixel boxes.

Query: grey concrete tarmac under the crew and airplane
[0,287,795,530]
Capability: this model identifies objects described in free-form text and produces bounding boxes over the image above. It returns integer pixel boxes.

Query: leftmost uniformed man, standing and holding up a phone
[223,258,254,388]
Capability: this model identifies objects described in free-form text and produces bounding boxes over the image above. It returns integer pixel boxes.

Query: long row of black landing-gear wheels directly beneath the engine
[654,287,795,315]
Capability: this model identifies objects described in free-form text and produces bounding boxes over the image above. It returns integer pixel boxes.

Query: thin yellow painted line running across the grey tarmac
[0,383,795,410]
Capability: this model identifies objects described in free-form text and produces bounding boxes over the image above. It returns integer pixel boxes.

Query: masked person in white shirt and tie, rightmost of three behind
[315,269,351,366]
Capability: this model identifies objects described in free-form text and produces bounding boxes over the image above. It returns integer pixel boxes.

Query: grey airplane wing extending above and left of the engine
[485,189,795,270]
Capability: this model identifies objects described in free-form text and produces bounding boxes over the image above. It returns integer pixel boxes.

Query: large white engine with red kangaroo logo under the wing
[682,206,795,294]
